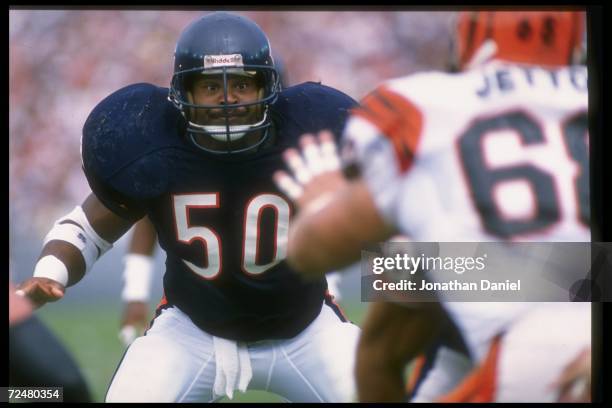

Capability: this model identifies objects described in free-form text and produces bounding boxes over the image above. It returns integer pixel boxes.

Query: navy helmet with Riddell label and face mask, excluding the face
[168,12,281,154]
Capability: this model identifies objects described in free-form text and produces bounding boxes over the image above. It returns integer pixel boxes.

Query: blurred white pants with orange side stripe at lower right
[440,302,591,402]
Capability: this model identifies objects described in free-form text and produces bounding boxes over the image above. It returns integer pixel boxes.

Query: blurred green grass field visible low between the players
[36,302,366,402]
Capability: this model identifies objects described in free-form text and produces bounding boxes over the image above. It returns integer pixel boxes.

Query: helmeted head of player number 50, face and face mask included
[168,13,280,154]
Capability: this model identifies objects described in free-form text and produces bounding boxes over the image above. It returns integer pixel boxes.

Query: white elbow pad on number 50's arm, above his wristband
[43,206,113,272]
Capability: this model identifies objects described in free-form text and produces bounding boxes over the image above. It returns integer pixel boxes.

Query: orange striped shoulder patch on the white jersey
[353,87,423,172]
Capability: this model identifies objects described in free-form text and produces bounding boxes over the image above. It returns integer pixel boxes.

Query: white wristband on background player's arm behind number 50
[121,254,153,302]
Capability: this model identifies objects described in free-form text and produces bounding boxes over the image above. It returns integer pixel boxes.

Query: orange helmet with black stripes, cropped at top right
[455,11,585,69]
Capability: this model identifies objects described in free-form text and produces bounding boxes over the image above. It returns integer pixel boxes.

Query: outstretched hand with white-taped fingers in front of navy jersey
[274,130,347,209]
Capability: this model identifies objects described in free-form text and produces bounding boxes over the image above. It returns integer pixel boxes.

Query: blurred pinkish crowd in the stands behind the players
[9,9,454,300]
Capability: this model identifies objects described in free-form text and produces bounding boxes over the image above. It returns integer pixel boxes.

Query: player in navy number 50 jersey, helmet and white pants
[15,12,359,402]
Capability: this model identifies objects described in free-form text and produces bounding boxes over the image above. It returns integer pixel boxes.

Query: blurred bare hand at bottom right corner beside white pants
[552,347,591,402]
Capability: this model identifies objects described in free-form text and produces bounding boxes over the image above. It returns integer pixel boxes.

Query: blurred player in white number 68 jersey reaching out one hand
[276,12,591,402]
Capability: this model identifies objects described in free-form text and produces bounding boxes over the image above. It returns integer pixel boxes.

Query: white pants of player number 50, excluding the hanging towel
[106,304,360,402]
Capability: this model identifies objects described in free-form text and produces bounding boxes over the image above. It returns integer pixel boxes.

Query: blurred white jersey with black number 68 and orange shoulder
[342,61,590,364]
